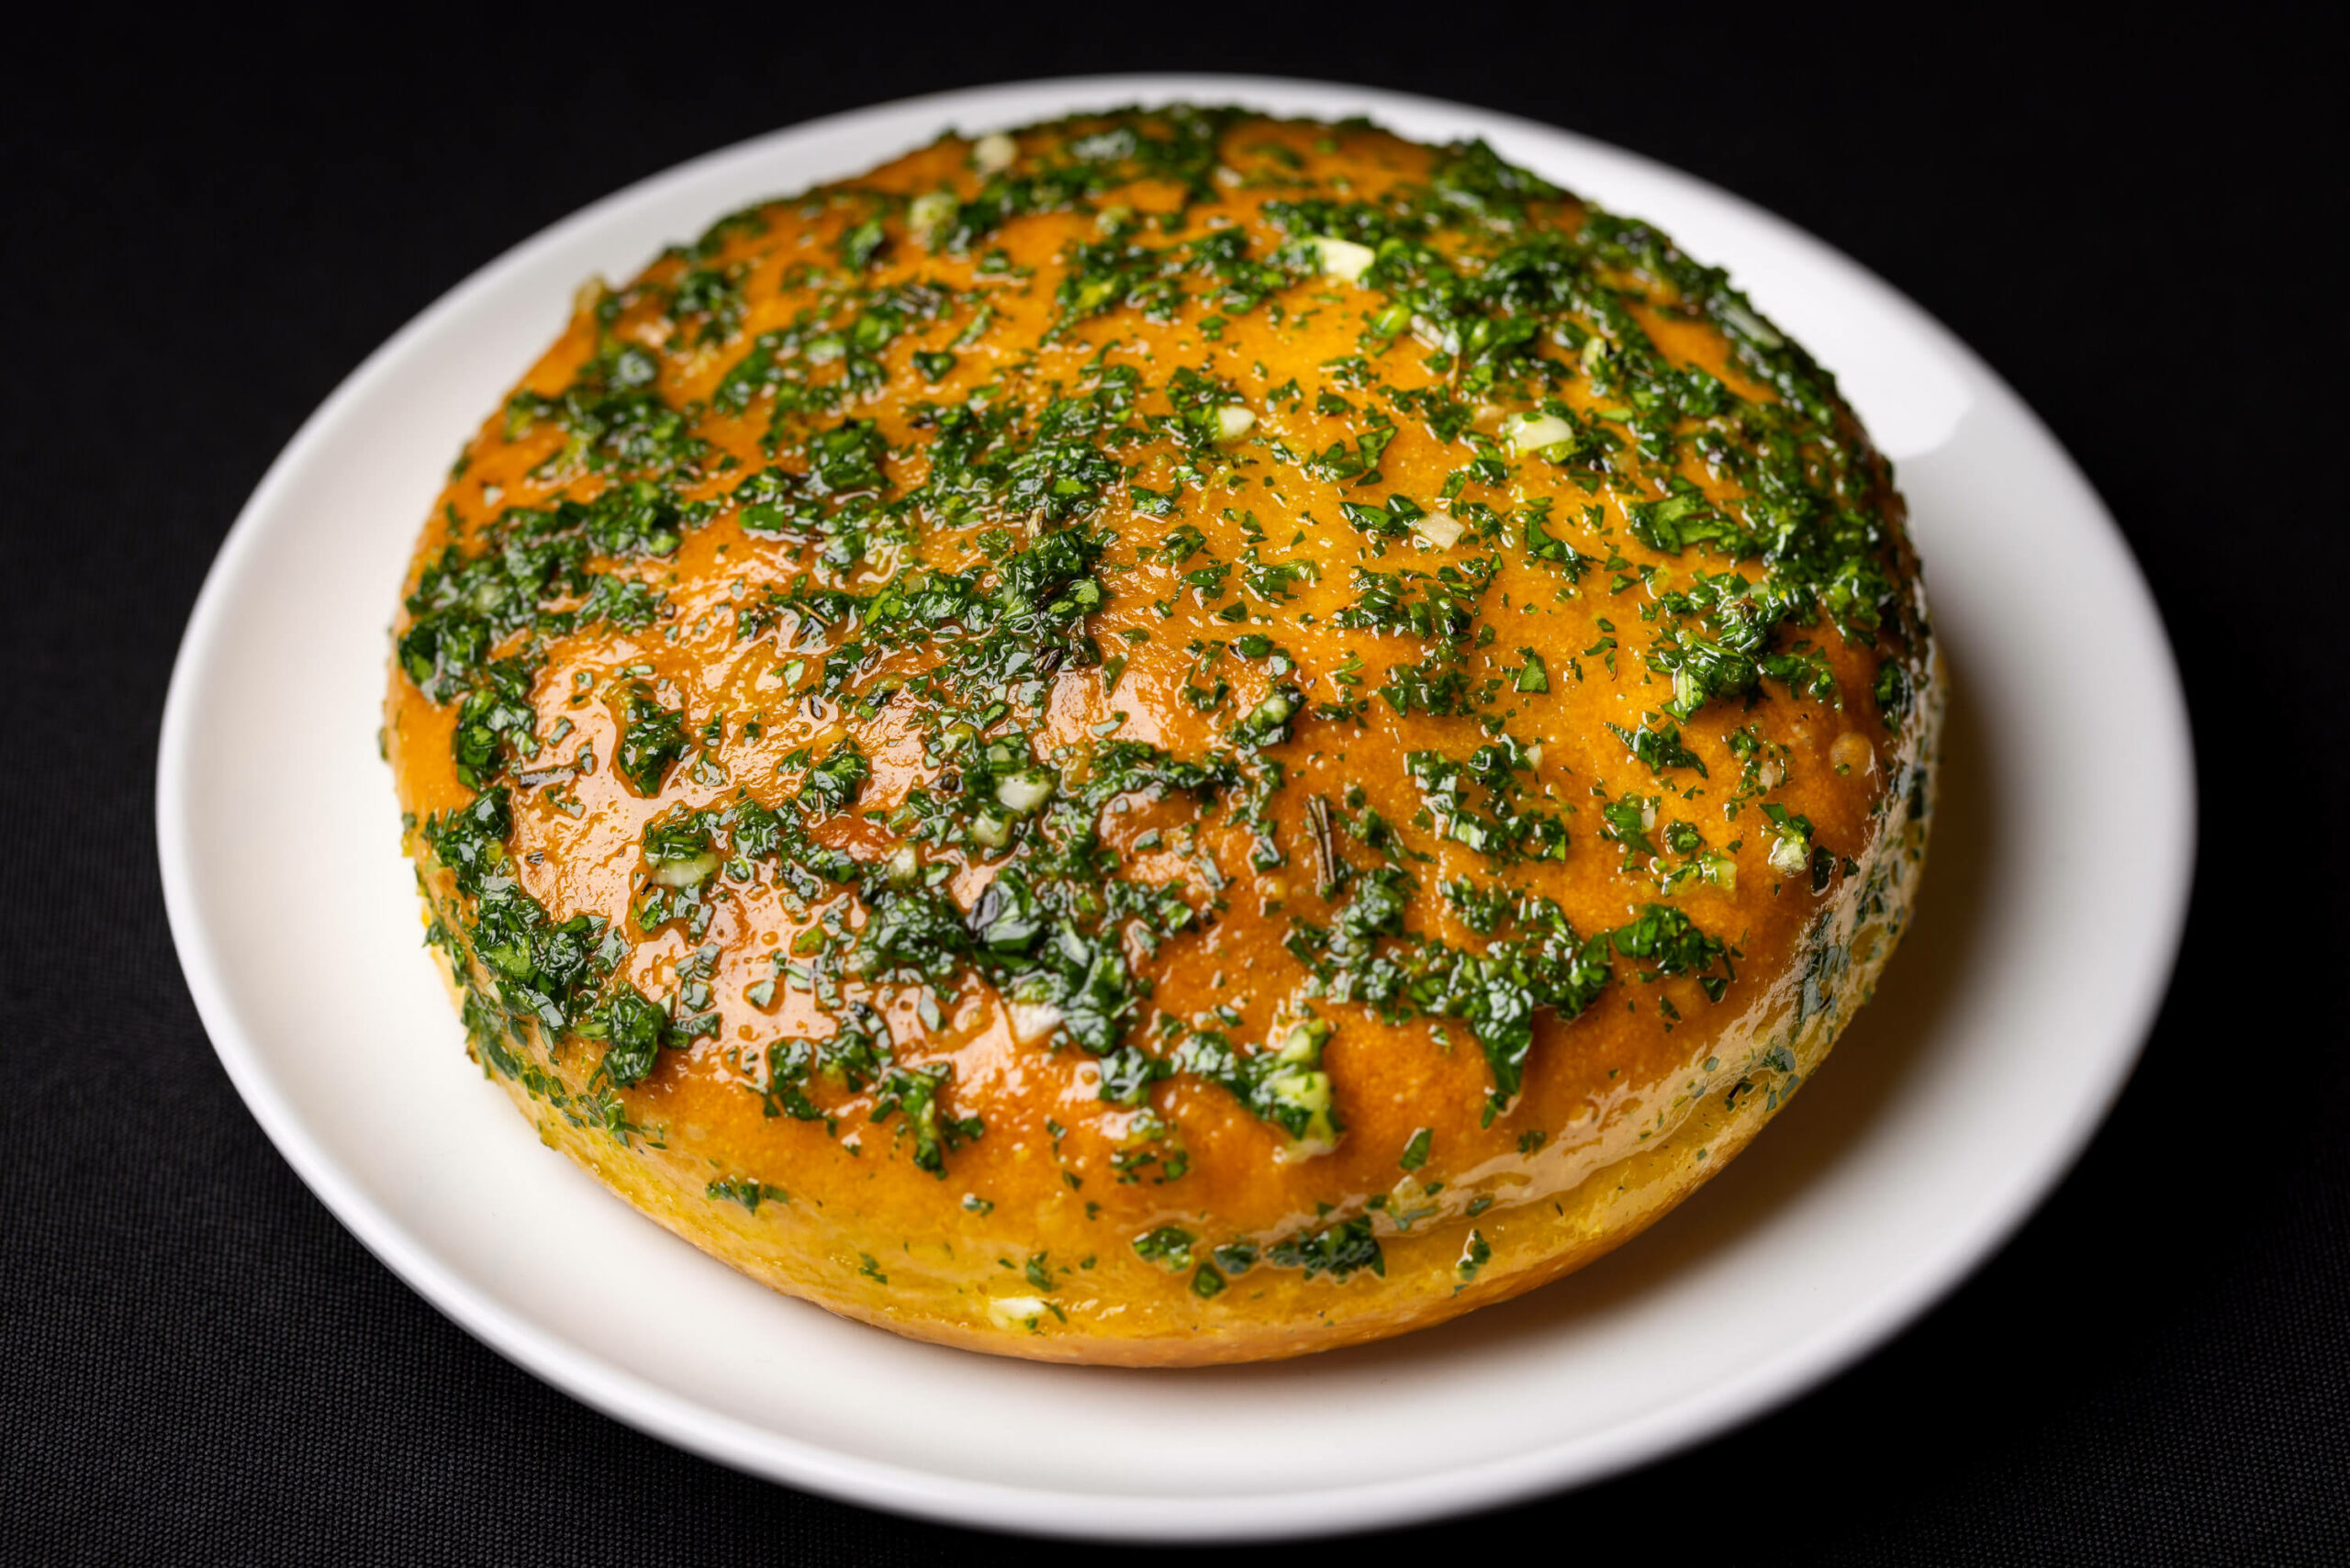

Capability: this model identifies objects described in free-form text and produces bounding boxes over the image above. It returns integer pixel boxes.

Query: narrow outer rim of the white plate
[155,73,2199,1542]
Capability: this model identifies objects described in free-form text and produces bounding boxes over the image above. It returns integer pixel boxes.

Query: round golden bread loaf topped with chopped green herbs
[386,108,1942,1363]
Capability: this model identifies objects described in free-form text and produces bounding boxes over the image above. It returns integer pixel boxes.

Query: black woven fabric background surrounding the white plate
[0,5,2350,1563]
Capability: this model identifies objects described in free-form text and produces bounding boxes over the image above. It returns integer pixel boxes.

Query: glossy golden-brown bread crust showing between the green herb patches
[387,120,1942,1366]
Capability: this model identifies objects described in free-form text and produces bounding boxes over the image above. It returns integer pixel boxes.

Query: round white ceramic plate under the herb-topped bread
[158,78,2192,1540]
